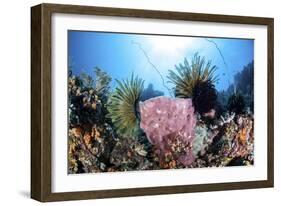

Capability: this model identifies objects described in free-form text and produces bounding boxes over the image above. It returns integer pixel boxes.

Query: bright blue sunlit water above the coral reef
[68,31,254,95]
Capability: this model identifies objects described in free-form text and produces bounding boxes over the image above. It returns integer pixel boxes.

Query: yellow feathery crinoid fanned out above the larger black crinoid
[168,53,217,98]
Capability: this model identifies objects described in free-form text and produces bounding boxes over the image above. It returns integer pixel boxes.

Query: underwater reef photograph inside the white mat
[66,30,254,174]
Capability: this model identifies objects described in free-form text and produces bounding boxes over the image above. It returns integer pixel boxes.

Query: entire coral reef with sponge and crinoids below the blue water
[68,57,254,174]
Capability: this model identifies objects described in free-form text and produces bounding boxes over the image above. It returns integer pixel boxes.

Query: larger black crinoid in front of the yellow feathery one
[192,80,217,114]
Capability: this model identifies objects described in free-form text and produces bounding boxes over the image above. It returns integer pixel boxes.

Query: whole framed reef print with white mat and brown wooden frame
[31,4,274,202]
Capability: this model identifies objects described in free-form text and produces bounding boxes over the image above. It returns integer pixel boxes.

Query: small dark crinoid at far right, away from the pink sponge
[227,93,245,114]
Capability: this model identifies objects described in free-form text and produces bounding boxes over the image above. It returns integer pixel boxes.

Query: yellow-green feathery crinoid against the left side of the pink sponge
[108,74,144,137]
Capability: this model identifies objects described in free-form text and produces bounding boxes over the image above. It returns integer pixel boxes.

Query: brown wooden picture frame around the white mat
[31,4,274,202]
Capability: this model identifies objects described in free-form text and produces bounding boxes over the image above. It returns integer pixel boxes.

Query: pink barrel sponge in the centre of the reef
[139,96,196,166]
